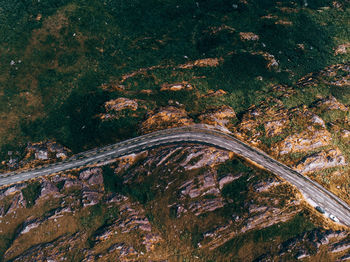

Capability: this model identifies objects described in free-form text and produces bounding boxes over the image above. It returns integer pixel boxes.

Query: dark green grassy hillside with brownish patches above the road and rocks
[0,0,350,162]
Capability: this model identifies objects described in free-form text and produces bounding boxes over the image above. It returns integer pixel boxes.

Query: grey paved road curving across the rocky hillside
[0,125,350,226]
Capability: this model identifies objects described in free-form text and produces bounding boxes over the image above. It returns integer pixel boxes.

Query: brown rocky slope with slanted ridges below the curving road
[0,138,350,261]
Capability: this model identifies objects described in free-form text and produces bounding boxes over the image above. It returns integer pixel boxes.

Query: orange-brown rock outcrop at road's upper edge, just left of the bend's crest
[141,106,193,133]
